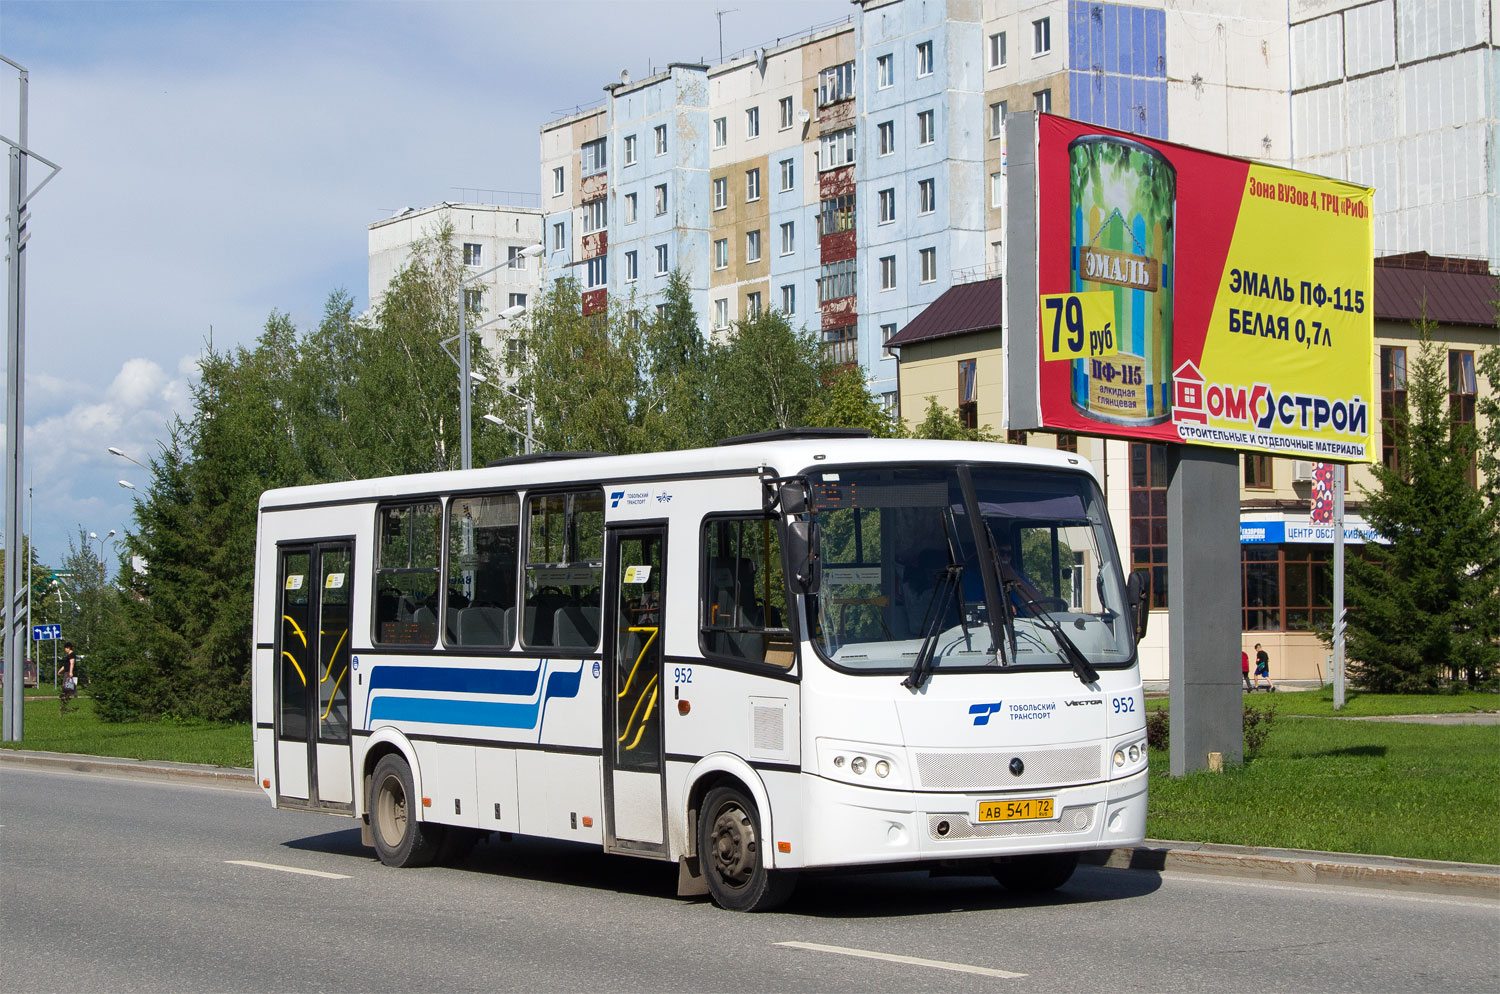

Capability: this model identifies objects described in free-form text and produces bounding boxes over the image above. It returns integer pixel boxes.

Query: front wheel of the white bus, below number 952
[698,787,797,912]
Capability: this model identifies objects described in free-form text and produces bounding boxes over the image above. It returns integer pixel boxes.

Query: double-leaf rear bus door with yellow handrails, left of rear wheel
[276,541,354,811]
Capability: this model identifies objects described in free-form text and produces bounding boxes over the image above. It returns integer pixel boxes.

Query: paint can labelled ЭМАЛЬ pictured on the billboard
[1068,135,1178,424]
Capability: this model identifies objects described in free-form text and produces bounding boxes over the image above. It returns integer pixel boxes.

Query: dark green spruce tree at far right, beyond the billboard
[1347,324,1500,693]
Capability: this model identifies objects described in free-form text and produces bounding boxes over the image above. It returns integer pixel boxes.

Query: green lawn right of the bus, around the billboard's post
[1146,710,1500,864]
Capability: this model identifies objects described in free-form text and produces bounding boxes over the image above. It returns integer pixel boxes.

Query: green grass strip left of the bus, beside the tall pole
[0,697,254,766]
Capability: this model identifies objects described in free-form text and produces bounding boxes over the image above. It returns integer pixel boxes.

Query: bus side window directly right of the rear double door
[374,501,438,646]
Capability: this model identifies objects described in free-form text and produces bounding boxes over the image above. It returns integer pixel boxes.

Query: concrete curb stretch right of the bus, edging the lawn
[1083,840,1500,900]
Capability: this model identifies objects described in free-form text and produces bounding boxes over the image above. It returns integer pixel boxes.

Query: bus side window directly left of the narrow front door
[521,490,605,649]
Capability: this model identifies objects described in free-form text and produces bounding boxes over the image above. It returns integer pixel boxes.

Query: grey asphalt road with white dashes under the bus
[0,766,1500,994]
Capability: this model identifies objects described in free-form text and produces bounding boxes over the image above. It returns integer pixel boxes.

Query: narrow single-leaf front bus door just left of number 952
[603,528,666,855]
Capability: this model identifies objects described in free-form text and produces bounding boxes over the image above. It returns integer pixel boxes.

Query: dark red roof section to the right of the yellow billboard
[1374,252,1500,328]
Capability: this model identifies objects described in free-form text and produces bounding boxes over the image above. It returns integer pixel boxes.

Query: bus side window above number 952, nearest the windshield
[701,517,792,667]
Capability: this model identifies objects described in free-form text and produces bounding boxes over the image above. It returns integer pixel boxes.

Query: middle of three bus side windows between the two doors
[447,493,521,648]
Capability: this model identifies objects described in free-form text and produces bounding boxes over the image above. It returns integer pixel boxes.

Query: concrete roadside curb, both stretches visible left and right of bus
[0,750,1500,901]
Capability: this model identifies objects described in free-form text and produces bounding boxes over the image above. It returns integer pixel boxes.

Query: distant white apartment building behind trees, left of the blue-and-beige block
[366,204,542,363]
